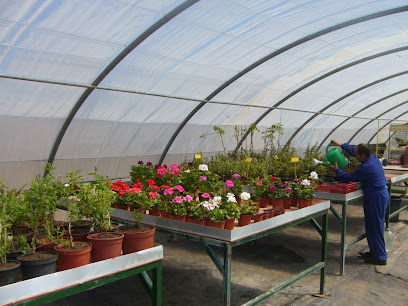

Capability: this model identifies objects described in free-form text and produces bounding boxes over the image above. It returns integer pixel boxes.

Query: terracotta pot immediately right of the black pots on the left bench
[54,241,92,271]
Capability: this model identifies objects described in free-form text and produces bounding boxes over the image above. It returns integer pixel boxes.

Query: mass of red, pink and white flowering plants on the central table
[111,162,318,226]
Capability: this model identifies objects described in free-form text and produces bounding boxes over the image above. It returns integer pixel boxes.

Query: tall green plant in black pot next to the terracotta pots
[17,167,62,279]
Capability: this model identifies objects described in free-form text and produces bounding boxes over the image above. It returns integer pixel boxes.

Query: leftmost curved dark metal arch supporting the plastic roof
[45,0,200,174]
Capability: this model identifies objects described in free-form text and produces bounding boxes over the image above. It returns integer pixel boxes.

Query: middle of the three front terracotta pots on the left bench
[87,232,124,262]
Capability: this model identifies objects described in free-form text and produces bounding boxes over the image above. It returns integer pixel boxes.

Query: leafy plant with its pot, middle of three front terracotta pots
[77,172,123,262]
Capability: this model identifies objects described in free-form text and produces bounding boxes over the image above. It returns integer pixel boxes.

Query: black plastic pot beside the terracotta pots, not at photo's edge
[17,252,58,280]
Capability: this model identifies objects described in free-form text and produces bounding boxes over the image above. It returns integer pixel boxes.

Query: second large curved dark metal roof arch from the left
[159,5,408,164]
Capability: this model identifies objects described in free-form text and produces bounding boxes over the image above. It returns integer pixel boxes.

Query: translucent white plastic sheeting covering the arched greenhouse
[0,0,408,185]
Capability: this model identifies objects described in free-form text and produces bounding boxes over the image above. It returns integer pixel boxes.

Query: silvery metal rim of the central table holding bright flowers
[111,199,330,242]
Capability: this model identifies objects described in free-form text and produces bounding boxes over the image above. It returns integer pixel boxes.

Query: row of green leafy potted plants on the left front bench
[0,168,153,285]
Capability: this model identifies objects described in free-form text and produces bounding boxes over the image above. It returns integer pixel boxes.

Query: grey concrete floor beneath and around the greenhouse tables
[49,200,408,305]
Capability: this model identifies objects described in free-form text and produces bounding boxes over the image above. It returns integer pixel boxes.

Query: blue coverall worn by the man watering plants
[336,143,390,260]
